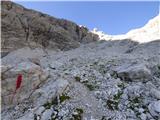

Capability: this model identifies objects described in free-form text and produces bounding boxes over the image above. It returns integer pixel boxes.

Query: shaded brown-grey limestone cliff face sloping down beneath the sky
[1,1,98,51]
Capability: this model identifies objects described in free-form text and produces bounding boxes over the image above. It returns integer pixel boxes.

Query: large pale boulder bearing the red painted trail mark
[2,62,49,108]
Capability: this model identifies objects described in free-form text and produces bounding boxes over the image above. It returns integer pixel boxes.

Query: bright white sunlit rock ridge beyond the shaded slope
[92,15,160,43]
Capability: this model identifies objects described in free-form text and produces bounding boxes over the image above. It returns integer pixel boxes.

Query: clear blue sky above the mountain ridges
[14,1,159,35]
